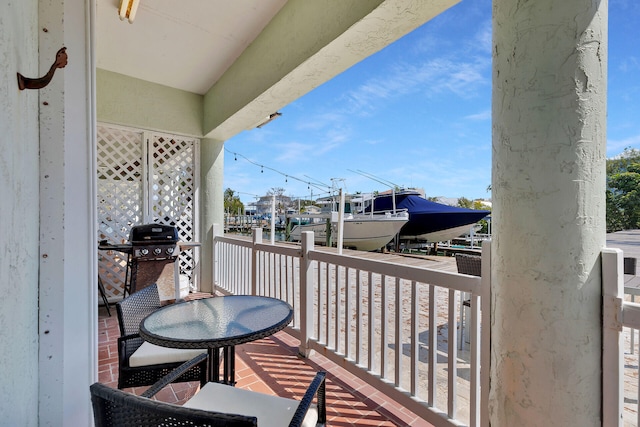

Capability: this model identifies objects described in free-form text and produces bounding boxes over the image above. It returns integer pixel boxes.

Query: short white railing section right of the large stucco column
[602,248,640,427]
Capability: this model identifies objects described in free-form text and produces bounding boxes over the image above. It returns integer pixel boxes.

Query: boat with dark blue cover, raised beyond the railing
[365,190,490,242]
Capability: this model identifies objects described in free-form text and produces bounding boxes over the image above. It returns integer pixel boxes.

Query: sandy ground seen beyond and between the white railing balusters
[221,230,640,426]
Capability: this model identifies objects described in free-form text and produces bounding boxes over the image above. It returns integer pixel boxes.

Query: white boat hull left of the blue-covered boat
[291,216,408,251]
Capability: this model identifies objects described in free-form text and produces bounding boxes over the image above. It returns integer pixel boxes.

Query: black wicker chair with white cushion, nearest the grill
[116,284,207,388]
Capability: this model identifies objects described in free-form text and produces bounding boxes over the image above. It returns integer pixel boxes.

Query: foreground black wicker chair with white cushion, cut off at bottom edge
[90,354,326,427]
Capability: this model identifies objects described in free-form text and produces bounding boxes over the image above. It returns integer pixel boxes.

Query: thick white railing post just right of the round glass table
[298,231,314,357]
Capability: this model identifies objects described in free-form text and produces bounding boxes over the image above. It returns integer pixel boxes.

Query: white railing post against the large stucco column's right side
[601,248,624,427]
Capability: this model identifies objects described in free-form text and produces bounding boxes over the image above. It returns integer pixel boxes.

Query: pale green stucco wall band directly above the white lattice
[96,70,203,137]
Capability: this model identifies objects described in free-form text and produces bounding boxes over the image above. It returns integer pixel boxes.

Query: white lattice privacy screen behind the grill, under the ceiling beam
[97,125,197,301]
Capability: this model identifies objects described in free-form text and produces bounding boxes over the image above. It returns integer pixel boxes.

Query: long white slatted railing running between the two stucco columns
[213,230,490,427]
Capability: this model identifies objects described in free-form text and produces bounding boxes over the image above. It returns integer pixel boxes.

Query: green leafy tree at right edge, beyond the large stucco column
[606,148,640,232]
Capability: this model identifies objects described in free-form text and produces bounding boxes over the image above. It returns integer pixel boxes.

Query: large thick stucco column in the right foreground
[490,0,607,427]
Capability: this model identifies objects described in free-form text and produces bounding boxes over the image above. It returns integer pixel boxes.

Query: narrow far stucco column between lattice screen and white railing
[200,138,224,292]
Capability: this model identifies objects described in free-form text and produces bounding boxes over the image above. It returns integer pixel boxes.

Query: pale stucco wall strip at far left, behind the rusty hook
[0,0,39,426]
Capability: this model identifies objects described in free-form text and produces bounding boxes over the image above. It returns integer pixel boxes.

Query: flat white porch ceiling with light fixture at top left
[96,0,287,94]
